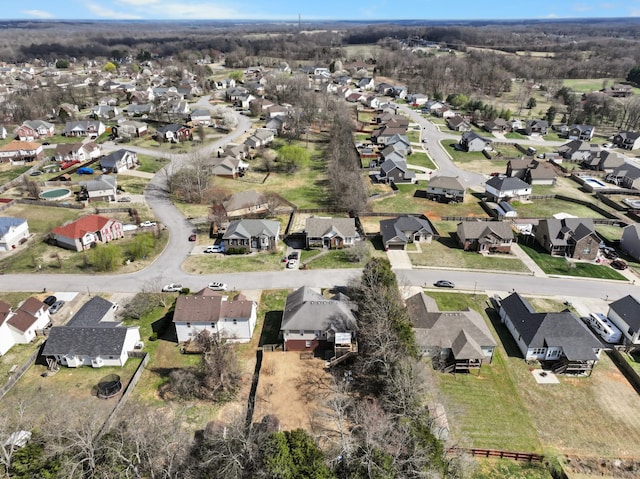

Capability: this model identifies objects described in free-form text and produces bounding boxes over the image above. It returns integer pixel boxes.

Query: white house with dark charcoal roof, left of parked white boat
[499,293,602,374]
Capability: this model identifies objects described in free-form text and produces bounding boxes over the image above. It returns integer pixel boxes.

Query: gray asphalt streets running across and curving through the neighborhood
[0,103,636,300]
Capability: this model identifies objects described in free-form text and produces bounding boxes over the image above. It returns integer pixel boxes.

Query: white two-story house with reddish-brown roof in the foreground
[173,288,257,343]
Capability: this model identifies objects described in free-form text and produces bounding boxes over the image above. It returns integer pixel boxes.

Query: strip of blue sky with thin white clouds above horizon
[8,0,640,20]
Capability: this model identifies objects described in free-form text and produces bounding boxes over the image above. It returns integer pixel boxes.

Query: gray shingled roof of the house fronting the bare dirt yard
[280,286,358,332]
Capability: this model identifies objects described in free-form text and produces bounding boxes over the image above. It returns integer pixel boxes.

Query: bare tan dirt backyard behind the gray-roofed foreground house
[253,352,332,430]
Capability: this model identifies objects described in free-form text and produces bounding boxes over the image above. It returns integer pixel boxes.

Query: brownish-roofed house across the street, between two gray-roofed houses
[304,216,360,249]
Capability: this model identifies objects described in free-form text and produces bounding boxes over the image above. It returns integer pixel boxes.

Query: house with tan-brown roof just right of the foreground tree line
[406,292,497,372]
